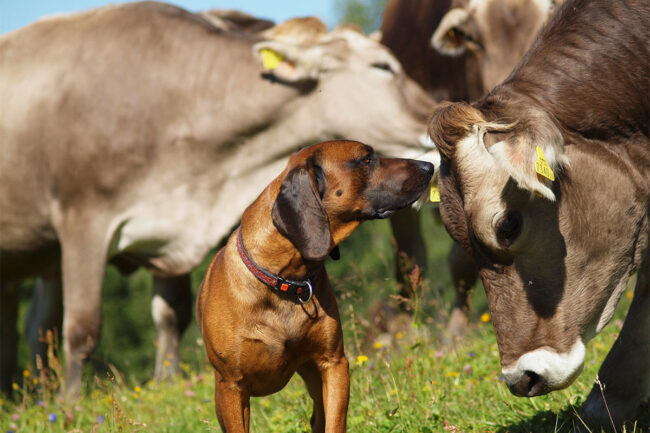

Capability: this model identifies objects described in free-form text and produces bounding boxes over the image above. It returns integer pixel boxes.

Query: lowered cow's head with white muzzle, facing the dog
[429,97,647,396]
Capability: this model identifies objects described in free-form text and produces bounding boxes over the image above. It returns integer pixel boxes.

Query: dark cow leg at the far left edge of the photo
[0,282,18,393]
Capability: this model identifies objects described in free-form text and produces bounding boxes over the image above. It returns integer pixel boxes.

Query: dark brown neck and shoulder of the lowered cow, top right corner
[494,0,650,140]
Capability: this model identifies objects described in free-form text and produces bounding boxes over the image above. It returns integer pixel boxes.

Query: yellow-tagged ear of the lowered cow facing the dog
[479,114,568,201]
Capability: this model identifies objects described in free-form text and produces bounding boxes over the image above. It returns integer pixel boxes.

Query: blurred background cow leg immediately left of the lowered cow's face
[447,242,478,337]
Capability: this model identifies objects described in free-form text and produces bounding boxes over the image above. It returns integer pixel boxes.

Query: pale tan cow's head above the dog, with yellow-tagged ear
[253,18,433,156]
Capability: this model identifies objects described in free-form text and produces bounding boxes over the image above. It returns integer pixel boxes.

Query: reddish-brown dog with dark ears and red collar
[197,141,433,433]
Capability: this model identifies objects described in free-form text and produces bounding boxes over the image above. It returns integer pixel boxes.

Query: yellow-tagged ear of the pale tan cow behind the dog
[253,40,345,83]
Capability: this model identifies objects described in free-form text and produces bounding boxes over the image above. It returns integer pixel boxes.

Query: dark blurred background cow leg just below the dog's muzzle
[390,208,427,299]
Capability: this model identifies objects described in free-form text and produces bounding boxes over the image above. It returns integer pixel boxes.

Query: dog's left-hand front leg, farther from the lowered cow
[214,370,250,433]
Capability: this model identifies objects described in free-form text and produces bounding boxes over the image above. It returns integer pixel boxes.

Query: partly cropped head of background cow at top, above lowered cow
[431,0,556,92]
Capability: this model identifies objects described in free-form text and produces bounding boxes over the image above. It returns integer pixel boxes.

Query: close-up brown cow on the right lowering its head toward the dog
[429,0,650,426]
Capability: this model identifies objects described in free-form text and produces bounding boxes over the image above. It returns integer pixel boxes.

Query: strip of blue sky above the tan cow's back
[0,0,337,34]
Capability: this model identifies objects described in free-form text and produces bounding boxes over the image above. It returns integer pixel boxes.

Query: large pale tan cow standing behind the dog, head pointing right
[0,3,431,396]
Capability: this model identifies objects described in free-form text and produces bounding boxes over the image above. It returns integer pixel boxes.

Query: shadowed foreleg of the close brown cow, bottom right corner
[582,253,650,429]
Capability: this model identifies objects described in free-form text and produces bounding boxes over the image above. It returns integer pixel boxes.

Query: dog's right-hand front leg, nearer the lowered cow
[320,356,350,433]
